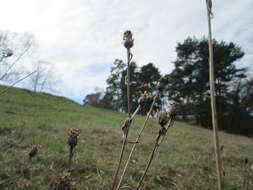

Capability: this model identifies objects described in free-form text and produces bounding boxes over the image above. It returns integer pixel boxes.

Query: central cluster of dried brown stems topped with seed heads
[112,30,176,190]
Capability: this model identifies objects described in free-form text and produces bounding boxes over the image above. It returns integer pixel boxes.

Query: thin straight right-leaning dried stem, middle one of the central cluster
[116,92,158,190]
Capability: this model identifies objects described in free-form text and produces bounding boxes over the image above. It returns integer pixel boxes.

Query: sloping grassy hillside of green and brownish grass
[0,86,253,190]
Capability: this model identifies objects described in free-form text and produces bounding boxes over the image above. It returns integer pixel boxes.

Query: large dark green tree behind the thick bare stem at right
[168,38,253,135]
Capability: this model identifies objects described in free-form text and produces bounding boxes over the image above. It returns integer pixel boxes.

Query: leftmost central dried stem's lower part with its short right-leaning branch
[112,105,141,190]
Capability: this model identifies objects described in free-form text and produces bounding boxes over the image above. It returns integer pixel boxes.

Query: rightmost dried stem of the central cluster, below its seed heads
[136,117,174,190]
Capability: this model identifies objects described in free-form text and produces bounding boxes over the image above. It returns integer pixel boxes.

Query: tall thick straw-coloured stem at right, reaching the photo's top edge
[206,0,224,190]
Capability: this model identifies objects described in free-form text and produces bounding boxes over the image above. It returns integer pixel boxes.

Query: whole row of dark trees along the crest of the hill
[84,37,253,135]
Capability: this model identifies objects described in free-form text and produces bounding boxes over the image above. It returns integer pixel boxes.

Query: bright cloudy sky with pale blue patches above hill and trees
[0,0,253,102]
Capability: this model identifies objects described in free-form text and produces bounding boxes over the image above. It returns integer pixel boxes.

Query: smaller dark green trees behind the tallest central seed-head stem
[100,59,161,114]
